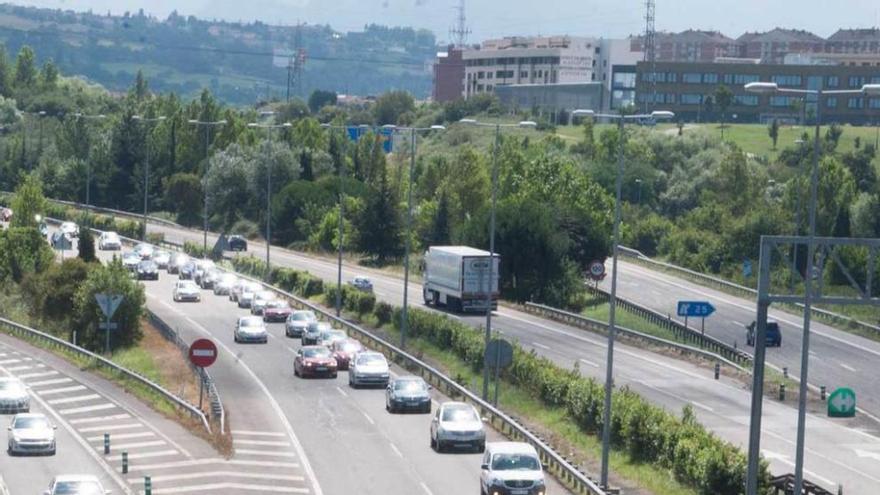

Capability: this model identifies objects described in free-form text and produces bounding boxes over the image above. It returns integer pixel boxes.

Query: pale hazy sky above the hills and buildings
[12,0,880,41]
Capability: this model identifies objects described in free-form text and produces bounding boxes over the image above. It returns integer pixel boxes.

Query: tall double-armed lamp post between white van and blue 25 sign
[574,106,675,487]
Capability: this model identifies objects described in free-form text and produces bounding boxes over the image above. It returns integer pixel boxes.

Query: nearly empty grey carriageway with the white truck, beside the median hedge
[143,225,880,495]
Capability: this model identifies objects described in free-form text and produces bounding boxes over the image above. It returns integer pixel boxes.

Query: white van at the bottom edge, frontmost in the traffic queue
[480,442,547,495]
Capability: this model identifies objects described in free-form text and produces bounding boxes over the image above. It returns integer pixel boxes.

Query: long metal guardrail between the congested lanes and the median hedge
[223,273,613,495]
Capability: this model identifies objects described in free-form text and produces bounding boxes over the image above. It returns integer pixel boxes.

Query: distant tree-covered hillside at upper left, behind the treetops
[0,5,436,104]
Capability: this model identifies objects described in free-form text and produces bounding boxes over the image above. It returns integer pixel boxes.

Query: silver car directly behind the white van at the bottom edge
[430,402,486,452]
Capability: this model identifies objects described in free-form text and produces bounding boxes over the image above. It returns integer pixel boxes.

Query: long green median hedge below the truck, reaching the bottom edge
[386,309,769,495]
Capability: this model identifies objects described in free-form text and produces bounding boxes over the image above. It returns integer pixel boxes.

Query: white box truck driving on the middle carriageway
[422,246,501,312]
